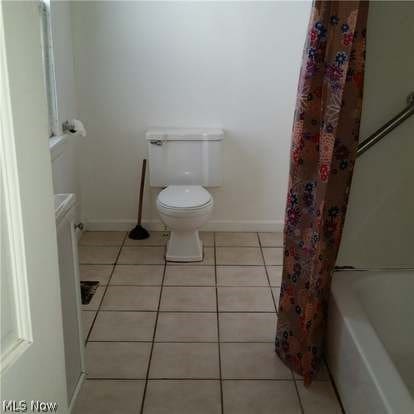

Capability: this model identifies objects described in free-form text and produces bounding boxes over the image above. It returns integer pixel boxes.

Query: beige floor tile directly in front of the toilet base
[164,265,216,286]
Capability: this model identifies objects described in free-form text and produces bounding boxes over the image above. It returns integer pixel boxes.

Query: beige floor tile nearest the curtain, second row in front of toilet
[218,287,275,312]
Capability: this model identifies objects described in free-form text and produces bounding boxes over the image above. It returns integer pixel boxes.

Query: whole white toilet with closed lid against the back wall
[146,128,224,262]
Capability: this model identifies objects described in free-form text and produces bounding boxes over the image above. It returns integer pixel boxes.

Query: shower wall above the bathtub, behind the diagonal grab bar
[338,2,414,268]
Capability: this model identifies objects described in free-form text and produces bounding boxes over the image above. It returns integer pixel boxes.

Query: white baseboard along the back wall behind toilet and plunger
[84,219,283,232]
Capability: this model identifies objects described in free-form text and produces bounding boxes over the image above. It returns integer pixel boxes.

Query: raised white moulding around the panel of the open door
[0,2,33,371]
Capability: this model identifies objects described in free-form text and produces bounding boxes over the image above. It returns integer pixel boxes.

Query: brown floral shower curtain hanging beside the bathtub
[276,1,368,385]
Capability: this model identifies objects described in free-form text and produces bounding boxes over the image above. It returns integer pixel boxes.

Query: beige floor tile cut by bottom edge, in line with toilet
[144,380,221,414]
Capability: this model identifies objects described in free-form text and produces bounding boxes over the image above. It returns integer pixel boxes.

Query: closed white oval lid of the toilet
[158,185,211,208]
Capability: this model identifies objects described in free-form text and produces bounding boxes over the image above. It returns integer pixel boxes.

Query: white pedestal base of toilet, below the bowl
[165,230,203,262]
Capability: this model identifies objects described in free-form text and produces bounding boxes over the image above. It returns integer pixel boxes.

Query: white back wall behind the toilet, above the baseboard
[72,1,310,230]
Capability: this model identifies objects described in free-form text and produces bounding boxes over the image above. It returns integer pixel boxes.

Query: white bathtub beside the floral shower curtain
[326,270,414,414]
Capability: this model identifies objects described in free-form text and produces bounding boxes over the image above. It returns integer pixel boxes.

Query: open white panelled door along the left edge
[0,1,68,413]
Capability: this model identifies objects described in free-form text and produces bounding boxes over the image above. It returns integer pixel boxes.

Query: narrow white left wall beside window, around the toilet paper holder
[51,1,80,220]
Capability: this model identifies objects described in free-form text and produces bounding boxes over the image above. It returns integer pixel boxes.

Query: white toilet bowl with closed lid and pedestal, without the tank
[157,185,214,262]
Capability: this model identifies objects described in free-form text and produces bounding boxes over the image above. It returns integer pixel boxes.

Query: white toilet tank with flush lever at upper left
[146,128,224,187]
